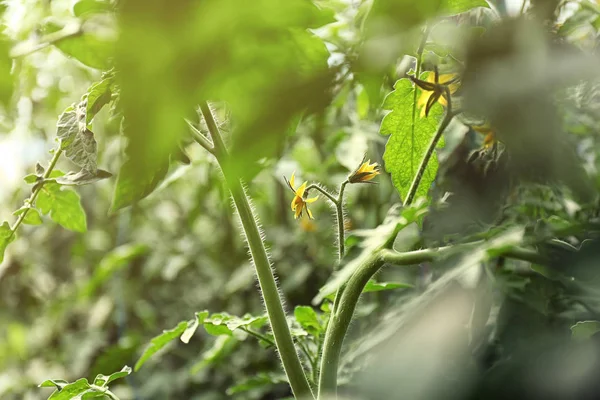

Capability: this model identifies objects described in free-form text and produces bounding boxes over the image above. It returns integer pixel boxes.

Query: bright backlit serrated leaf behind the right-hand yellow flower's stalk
[380,79,443,199]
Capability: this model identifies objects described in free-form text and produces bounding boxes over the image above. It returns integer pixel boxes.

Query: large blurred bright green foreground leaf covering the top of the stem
[118,0,332,192]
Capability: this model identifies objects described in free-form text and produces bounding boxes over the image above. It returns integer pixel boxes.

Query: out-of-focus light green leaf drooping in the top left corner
[43,21,114,70]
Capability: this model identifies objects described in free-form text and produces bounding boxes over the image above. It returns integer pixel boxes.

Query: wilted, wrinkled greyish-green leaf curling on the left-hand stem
[56,102,98,174]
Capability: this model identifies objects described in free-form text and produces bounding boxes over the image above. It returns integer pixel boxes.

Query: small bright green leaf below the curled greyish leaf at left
[36,182,87,232]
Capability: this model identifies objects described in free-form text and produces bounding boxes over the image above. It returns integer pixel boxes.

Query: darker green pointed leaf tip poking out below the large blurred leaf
[111,160,169,212]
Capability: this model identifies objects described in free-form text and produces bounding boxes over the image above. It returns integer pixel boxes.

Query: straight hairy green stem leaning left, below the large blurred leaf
[200,102,313,398]
